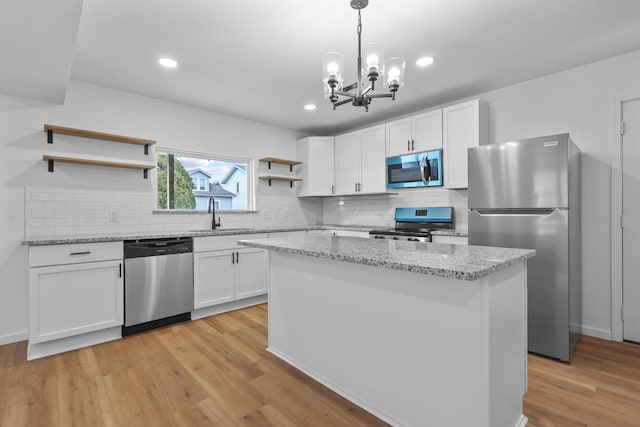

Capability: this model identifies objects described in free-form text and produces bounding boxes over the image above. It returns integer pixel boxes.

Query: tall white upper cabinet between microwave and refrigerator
[442,99,489,189]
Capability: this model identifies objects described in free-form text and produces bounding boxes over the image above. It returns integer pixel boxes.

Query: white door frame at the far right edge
[611,91,640,341]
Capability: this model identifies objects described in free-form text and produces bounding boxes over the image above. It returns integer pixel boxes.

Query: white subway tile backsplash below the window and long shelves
[25,187,322,238]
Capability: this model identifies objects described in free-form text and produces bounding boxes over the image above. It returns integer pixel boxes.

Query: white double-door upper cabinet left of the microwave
[335,125,387,195]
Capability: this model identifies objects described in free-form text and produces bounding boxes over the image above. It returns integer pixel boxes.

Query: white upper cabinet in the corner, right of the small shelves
[296,137,335,197]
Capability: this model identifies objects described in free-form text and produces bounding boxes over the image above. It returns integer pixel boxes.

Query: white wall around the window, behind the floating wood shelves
[0,81,321,344]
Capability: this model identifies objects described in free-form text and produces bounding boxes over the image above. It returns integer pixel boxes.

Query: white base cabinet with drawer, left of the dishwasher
[28,242,124,359]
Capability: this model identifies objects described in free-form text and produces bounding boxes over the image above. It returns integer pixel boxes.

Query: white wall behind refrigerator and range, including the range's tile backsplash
[323,50,640,339]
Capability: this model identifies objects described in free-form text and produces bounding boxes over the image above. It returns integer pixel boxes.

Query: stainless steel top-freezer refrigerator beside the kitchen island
[468,134,582,361]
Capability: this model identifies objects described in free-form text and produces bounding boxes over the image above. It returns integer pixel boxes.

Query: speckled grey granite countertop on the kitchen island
[238,235,536,280]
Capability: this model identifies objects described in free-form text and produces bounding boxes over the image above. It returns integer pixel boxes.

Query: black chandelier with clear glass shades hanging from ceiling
[322,0,404,112]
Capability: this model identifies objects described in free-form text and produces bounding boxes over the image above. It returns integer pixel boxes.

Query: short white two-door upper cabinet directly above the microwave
[387,110,442,157]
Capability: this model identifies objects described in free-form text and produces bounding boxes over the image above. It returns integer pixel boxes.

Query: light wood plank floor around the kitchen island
[0,305,640,427]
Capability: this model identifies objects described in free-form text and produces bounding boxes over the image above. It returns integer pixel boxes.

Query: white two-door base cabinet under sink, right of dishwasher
[193,234,269,309]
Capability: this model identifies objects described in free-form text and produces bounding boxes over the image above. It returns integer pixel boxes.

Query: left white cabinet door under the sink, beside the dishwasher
[193,250,235,309]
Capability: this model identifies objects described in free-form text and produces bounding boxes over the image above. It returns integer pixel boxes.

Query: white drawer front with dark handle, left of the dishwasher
[29,241,124,267]
